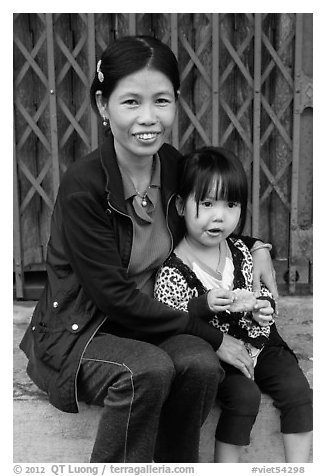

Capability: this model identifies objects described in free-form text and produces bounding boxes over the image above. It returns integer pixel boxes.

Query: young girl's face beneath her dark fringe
[177,188,241,248]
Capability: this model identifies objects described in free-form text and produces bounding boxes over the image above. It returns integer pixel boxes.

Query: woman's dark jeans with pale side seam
[78,333,224,463]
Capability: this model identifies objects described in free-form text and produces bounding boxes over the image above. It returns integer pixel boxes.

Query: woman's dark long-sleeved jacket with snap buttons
[20,136,255,412]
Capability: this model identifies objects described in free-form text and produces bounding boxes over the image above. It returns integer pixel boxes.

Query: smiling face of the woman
[106,68,176,162]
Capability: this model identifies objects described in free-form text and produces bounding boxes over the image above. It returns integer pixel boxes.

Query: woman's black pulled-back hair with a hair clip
[90,36,180,113]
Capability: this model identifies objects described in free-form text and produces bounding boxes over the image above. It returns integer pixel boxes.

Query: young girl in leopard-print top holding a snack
[155,147,312,462]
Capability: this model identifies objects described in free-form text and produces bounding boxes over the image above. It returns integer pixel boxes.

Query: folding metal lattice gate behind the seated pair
[14,13,312,298]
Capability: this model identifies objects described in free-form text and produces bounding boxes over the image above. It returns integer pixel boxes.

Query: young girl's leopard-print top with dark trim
[154,237,274,348]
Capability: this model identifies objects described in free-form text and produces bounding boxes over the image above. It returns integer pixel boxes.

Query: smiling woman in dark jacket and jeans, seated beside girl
[21,37,275,463]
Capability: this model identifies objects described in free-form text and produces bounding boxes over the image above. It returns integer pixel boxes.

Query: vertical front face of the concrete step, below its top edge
[14,395,312,463]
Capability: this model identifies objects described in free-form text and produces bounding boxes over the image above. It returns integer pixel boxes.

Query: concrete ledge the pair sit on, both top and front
[13,296,313,463]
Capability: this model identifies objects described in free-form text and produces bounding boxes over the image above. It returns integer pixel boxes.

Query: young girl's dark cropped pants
[216,346,312,445]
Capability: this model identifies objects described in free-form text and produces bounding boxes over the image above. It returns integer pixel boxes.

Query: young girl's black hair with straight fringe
[179,147,248,234]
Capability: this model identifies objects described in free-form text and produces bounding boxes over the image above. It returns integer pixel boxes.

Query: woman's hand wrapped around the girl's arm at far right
[252,248,278,301]
